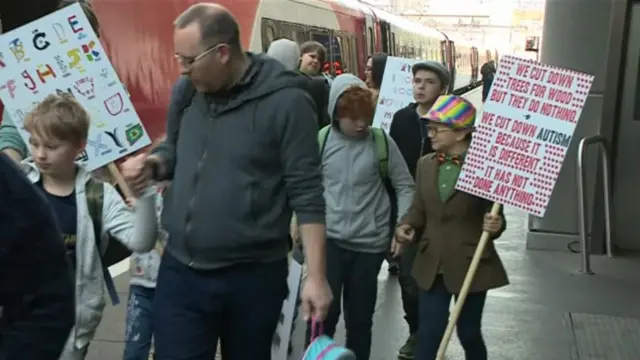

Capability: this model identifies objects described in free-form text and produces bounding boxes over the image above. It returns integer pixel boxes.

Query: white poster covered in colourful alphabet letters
[0,4,151,170]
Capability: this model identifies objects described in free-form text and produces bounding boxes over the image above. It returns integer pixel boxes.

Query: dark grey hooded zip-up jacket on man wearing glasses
[154,53,325,269]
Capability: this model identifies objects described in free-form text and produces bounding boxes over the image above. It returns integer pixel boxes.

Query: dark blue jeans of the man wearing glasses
[153,251,289,360]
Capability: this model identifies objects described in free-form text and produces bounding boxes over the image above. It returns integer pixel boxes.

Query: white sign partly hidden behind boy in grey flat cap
[373,56,419,132]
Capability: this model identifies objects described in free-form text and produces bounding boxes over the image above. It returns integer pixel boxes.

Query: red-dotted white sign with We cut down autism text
[456,56,593,217]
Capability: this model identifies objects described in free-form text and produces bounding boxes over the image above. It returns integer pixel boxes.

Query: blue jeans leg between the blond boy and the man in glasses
[123,285,155,360]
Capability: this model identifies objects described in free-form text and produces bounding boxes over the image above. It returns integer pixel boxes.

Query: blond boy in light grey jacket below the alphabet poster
[21,93,157,360]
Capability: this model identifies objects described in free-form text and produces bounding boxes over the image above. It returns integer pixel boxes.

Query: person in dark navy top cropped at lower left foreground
[0,154,75,360]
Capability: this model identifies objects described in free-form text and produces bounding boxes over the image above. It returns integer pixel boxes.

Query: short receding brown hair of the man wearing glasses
[174,3,242,51]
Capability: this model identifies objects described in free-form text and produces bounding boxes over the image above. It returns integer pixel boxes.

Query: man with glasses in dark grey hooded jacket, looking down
[122,3,331,360]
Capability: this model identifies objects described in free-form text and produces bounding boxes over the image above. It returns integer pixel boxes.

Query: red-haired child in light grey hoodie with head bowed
[308,74,415,360]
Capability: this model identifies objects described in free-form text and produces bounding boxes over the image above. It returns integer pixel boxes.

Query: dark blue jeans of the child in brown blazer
[415,275,487,360]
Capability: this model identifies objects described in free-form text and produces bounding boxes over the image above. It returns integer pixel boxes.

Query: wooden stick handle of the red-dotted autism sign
[436,203,500,360]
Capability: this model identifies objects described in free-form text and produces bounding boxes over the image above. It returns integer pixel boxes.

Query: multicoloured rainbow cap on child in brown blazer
[422,95,476,130]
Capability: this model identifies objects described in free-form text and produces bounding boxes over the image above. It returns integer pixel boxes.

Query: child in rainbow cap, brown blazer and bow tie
[396,95,509,360]
